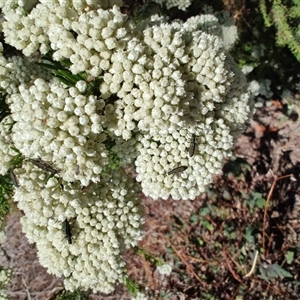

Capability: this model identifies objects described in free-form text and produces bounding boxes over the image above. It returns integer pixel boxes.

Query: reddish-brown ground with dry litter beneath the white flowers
[0,96,300,300]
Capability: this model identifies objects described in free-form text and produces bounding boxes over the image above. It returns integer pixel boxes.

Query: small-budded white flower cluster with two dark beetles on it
[135,119,233,200]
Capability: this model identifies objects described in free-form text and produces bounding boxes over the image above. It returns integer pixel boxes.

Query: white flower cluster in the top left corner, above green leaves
[3,0,134,76]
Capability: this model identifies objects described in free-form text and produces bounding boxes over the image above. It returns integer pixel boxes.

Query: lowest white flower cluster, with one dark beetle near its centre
[14,162,143,293]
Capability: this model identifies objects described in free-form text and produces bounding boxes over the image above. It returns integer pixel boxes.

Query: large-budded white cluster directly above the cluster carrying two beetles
[105,19,234,140]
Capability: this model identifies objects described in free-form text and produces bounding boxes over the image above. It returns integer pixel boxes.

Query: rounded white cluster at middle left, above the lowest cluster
[7,78,107,185]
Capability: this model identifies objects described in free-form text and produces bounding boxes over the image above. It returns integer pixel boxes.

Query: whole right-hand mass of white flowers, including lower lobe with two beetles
[108,15,253,199]
